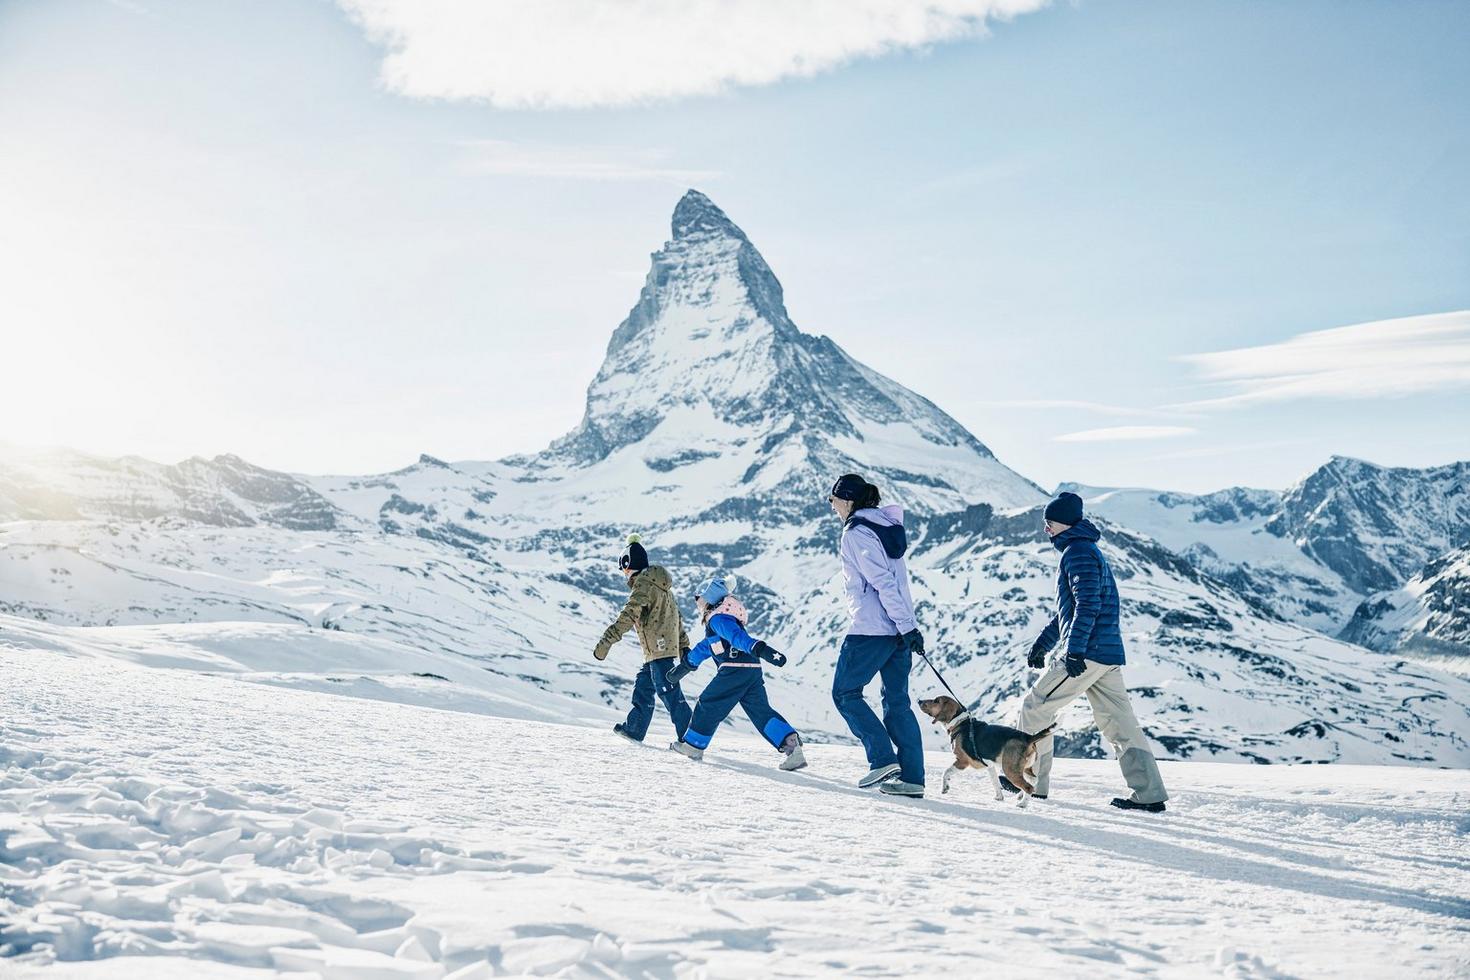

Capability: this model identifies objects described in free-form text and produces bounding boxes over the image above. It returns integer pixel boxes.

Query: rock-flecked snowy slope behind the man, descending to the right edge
[846,513,1470,765]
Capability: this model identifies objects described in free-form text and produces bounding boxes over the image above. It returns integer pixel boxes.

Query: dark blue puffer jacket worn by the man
[1036,520,1123,664]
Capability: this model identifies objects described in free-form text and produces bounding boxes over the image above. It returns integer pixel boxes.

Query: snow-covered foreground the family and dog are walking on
[0,632,1470,977]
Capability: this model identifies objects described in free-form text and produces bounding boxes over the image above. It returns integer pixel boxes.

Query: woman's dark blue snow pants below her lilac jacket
[832,635,923,786]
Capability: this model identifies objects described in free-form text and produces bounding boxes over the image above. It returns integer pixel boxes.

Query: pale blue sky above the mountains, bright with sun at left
[0,0,1470,489]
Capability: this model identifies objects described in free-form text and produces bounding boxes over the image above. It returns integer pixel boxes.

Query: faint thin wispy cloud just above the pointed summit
[459,140,720,187]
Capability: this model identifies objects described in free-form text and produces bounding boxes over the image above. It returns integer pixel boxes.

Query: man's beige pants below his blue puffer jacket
[1016,660,1169,804]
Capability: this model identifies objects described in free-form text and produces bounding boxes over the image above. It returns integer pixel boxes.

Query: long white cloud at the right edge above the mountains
[1176,310,1470,408]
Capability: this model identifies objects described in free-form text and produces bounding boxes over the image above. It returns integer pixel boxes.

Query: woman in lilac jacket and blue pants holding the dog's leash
[828,473,923,796]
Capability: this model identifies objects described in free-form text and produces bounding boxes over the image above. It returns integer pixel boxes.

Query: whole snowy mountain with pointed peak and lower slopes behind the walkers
[0,192,1470,765]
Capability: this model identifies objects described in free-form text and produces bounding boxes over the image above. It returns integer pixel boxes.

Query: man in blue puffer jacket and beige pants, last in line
[1007,494,1169,813]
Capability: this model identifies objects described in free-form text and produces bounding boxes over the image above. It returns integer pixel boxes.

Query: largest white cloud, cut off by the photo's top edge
[338,0,1048,109]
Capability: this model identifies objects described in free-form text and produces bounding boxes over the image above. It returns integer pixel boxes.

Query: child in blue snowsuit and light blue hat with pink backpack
[669,579,807,770]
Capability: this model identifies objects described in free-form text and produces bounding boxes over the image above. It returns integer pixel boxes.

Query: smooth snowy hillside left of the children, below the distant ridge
[0,522,649,728]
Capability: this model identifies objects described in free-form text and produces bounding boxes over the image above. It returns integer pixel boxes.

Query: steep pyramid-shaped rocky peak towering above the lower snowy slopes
[539,190,1042,511]
